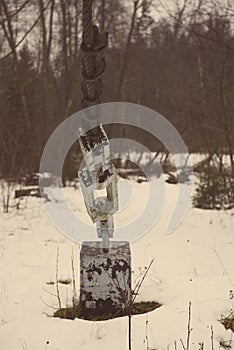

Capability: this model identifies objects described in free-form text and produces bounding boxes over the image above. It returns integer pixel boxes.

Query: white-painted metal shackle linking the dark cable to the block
[78,126,118,250]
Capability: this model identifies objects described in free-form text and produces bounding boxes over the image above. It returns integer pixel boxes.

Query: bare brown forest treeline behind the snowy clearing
[0,0,234,177]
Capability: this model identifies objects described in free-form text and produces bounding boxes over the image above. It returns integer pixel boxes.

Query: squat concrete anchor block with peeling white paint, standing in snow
[80,241,131,319]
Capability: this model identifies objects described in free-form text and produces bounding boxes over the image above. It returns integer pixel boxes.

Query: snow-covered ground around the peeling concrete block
[0,180,234,350]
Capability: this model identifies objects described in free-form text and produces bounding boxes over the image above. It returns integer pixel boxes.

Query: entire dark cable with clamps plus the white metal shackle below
[78,0,118,251]
